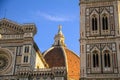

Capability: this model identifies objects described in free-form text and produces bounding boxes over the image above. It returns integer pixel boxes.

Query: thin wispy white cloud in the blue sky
[37,12,72,22]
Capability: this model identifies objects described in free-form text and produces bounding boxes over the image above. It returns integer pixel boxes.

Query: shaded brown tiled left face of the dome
[44,48,65,68]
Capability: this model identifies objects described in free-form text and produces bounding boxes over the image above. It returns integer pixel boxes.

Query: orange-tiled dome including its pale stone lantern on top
[43,27,80,80]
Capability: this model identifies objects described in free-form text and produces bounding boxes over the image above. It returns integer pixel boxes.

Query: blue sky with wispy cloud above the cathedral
[0,0,80,55]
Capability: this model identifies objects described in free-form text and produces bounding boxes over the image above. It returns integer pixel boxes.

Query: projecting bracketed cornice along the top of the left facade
[0,18,37,34]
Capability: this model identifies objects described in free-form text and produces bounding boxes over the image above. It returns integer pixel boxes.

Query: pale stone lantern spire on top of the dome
[53,25,66,47]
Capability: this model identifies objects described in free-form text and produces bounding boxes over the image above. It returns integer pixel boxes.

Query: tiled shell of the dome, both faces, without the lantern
[44,47,80,80]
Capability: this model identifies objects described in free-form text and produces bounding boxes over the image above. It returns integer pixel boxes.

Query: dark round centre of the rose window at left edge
[0,55,9,71]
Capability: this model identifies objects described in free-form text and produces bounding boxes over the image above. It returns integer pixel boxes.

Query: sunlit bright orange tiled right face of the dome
[65,48,80,80]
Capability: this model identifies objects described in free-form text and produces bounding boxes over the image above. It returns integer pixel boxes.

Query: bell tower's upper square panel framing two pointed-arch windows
[85,6,115,37]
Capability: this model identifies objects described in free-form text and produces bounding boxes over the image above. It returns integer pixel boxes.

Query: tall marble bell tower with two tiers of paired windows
[80,0,120,80]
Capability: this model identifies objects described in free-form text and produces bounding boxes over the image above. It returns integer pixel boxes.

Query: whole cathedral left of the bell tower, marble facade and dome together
[0,18,80,80]
